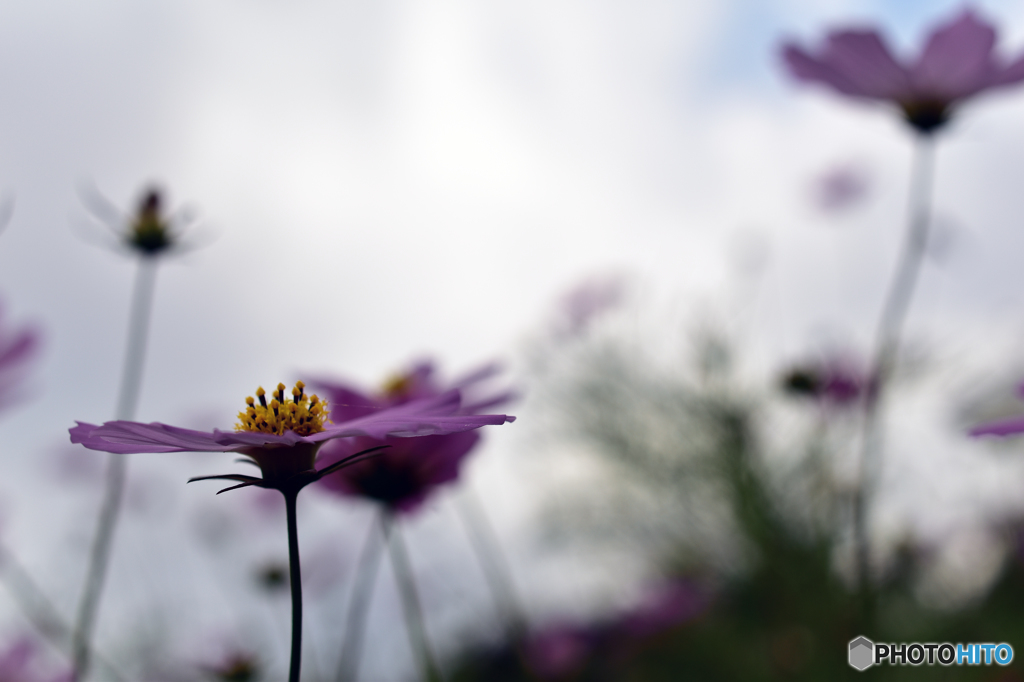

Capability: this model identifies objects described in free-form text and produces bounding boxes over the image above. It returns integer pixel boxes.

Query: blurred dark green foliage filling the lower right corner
[453,337,1024,682]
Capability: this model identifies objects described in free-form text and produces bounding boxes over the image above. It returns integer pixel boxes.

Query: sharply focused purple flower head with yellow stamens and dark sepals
[70,381,515,493]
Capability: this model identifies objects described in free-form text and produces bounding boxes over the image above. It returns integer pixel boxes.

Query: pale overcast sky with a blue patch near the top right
[0,0,1024,675]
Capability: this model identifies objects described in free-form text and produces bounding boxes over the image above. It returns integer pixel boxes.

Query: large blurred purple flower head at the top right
[782,9,1024,133]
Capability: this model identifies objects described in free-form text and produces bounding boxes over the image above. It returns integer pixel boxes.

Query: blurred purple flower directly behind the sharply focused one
[307,363,511,512]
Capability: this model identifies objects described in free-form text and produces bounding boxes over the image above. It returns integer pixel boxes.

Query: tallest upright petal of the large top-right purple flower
[910,10,996,101]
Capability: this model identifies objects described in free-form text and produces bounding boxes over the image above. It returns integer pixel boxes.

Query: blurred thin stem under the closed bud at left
[72,257,157,682]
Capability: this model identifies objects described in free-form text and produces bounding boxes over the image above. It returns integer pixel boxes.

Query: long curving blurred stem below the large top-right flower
[852,134,935,593]
